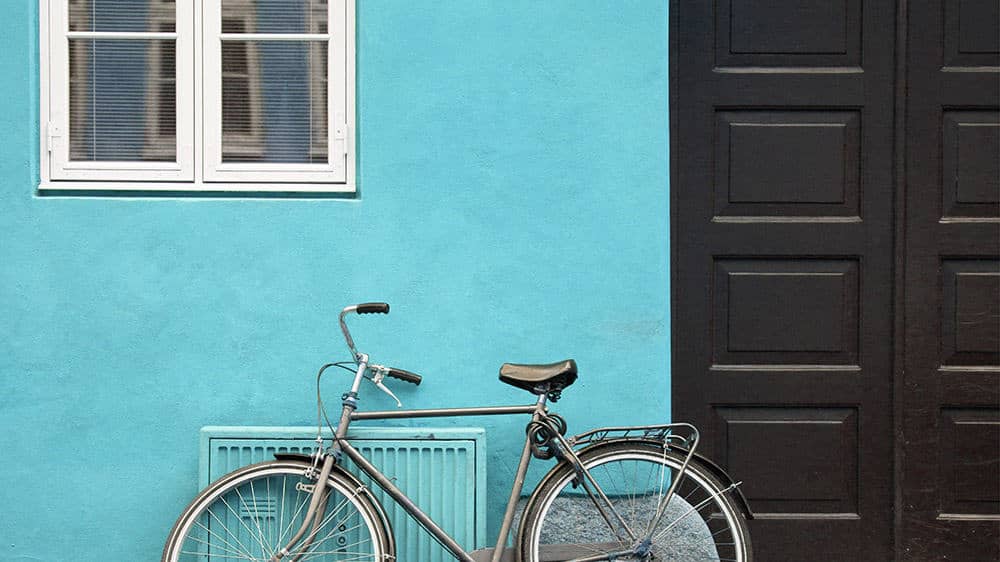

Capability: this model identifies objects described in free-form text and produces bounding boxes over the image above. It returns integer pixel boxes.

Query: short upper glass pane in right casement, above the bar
[222,0,327,33]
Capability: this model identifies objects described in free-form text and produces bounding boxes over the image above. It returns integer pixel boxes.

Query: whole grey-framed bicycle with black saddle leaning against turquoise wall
[162,303,753,562]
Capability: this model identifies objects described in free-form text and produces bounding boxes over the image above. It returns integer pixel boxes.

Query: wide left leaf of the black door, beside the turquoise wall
[671,0,895,562]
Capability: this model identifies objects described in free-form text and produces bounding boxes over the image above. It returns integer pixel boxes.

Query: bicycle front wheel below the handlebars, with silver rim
[162,461,395,562]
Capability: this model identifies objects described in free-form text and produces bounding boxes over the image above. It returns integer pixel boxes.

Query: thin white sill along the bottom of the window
[38,181,357,199]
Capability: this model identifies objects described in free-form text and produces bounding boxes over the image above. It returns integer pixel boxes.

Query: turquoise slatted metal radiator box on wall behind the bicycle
[199,426,486,562]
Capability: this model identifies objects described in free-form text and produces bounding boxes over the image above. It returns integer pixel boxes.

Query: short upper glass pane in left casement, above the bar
[69,0,177,32]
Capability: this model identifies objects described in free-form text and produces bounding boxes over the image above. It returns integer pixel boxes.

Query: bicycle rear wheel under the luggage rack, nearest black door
[520,441,752,562]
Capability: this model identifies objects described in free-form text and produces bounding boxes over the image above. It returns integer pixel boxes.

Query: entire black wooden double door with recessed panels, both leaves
[671,0,1000,562]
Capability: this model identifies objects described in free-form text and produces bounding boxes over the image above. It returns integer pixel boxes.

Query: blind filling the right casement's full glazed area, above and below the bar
[214,0,330,164]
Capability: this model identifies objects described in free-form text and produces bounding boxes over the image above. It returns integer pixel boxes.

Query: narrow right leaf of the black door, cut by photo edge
[898,0,1000,562]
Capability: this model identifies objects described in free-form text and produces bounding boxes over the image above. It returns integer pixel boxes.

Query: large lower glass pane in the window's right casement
[221,41,328,164]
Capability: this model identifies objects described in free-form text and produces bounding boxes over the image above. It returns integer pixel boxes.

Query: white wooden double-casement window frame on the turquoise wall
[39,0,356,193]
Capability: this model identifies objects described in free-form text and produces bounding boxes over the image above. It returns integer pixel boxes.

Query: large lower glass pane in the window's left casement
[69,39,177,162]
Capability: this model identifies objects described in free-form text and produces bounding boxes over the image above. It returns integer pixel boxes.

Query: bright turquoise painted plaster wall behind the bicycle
[0,0,670,561]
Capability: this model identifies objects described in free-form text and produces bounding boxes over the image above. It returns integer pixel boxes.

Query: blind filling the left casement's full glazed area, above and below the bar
[66,0,177,162]
